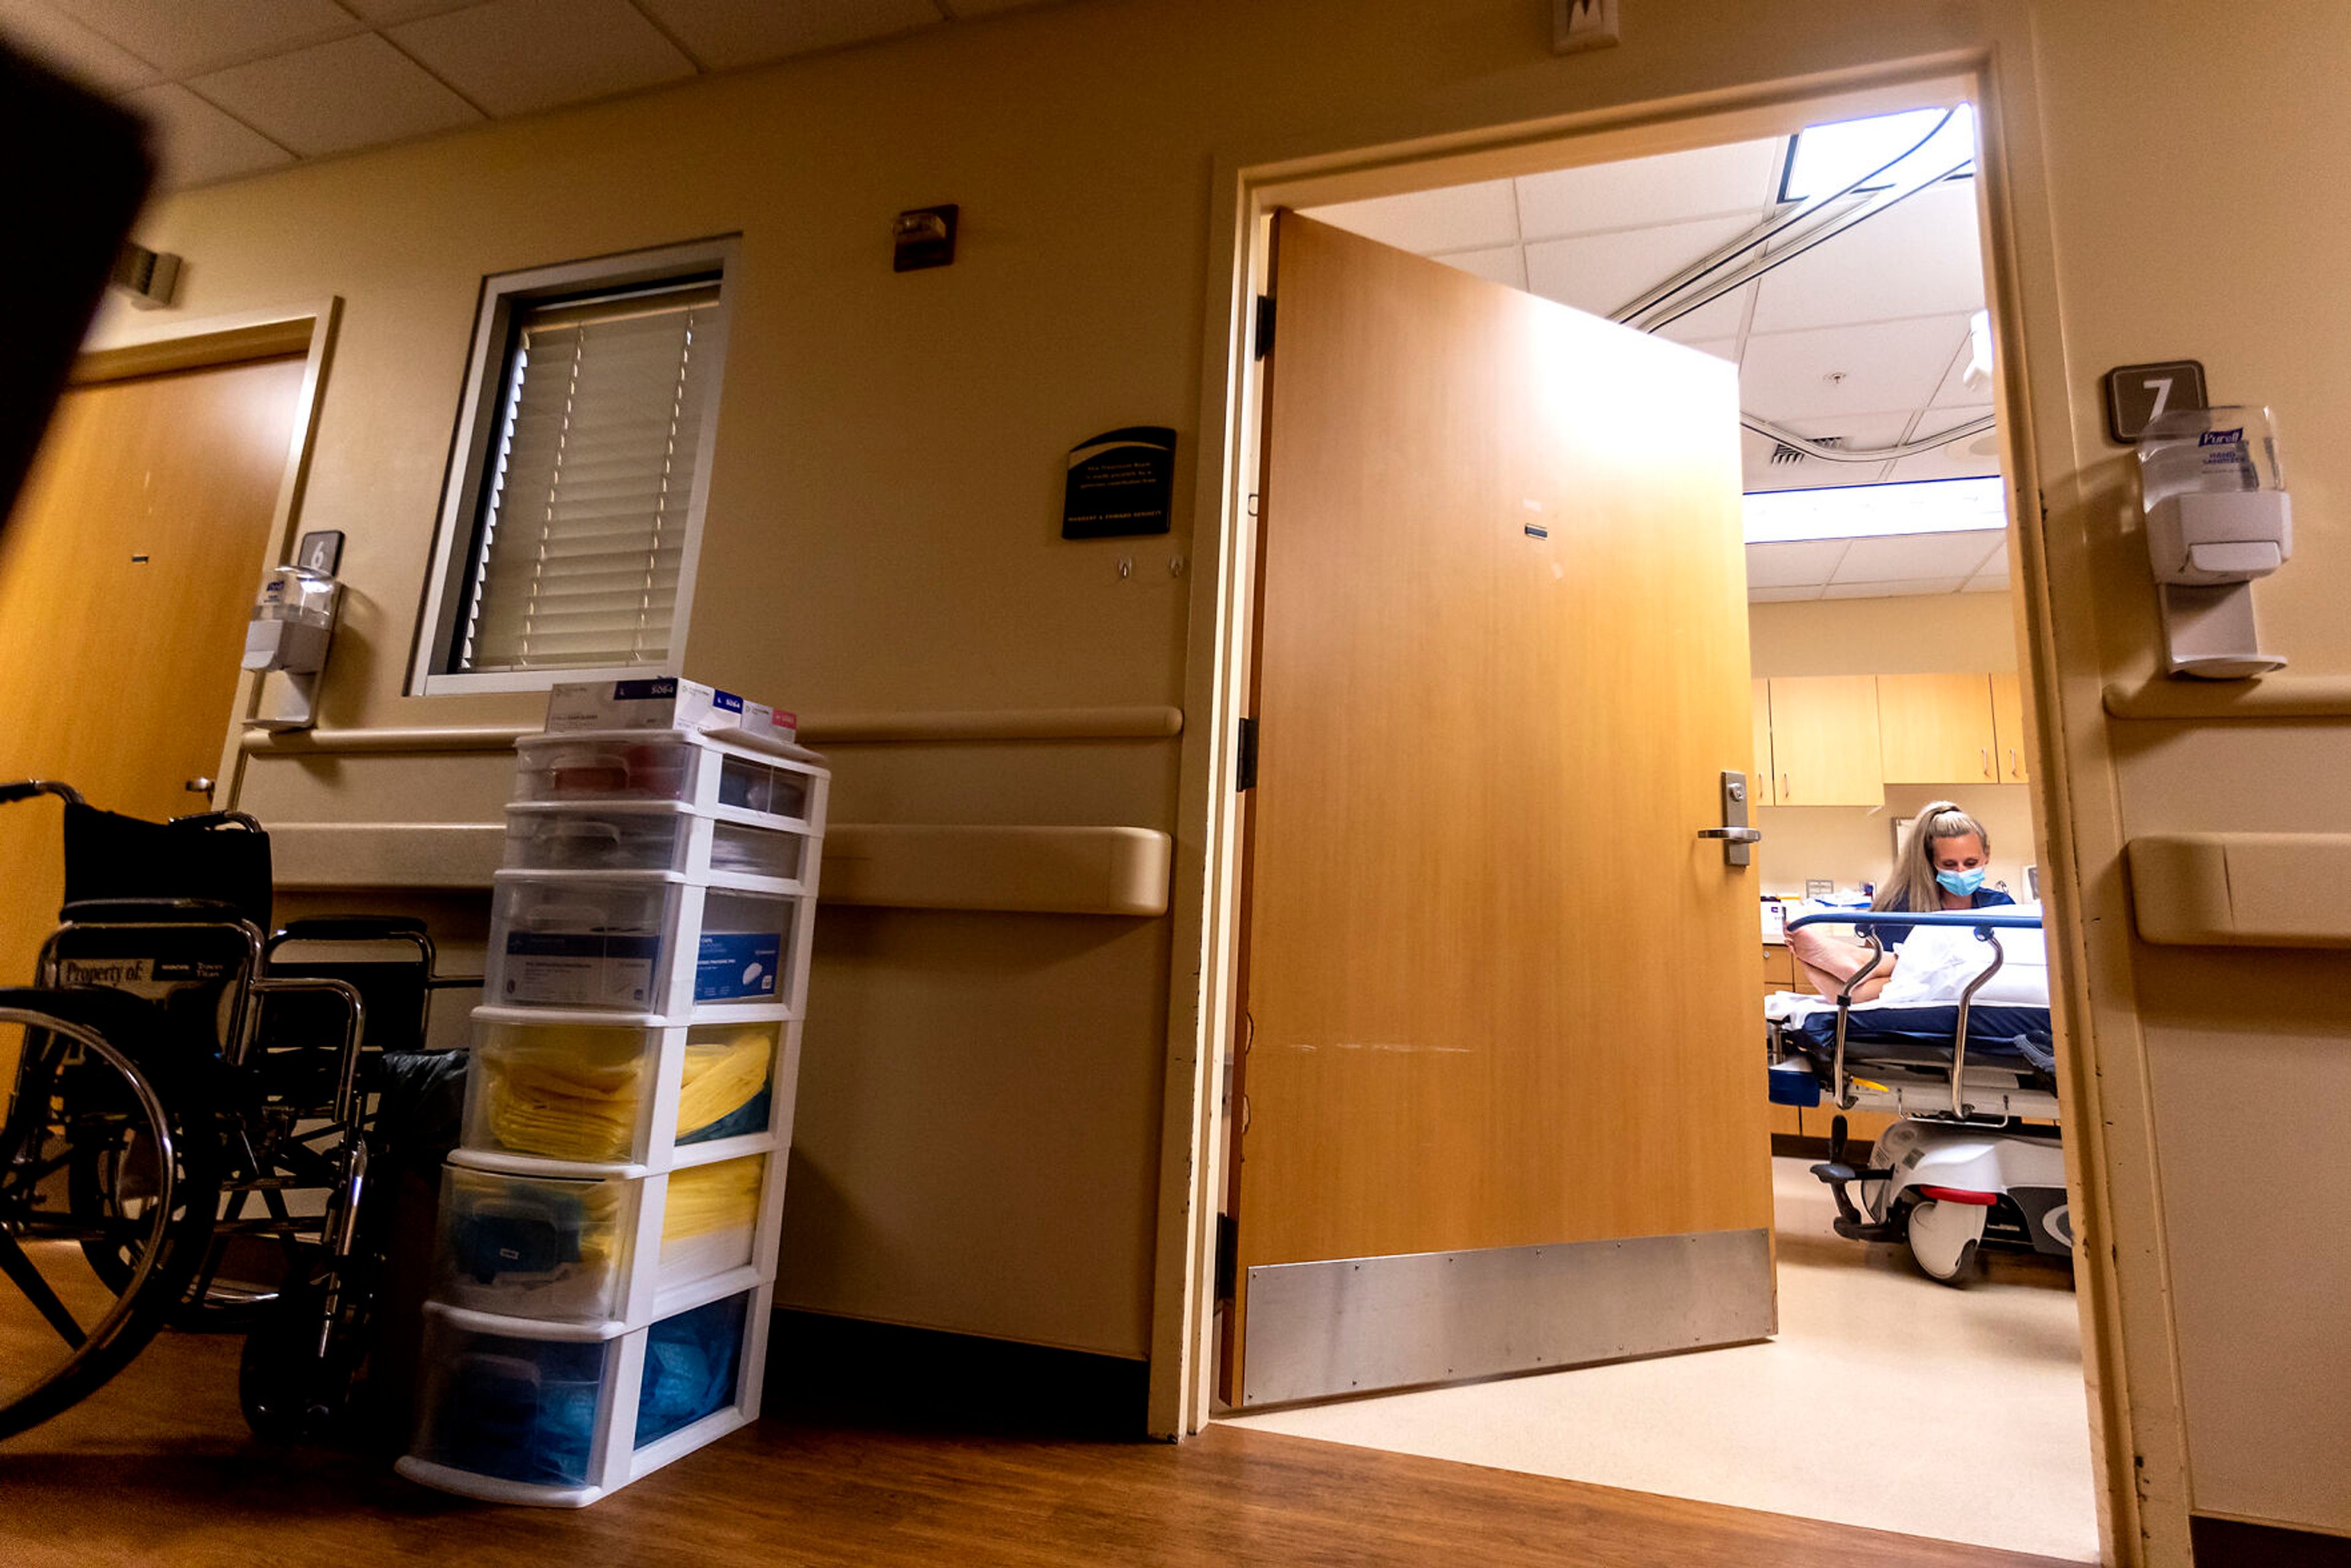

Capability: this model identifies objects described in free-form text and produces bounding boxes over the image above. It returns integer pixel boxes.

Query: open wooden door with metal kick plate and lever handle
[1223,212,1775,1406]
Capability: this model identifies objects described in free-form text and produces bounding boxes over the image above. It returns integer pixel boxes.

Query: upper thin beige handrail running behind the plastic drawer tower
[244,705,1183,757]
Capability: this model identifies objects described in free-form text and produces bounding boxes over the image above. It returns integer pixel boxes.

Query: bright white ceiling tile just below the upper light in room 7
[1756,179,1984,331]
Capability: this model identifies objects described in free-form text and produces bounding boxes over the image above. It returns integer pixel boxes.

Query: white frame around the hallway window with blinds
[409,235,738,696]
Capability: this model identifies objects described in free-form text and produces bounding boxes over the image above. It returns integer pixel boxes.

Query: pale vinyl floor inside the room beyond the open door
[1227,1159,2097,1561]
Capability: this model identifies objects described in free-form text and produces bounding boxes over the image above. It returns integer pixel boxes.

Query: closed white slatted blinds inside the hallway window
[454,285,719,672]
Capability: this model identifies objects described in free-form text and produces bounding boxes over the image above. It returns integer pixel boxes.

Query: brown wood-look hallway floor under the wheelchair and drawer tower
[0,1335,2097,1568]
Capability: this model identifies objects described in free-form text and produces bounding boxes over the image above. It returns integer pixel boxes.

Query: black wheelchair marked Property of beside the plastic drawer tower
[0,781,479,1439]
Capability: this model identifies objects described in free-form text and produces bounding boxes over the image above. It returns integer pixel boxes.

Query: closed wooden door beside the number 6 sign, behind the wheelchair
[0,355,303,987]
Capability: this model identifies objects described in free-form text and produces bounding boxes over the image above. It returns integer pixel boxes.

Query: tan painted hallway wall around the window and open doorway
[73,0,2351,1549]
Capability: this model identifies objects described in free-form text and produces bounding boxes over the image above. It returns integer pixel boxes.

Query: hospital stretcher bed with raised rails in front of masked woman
[1766,910,2074,1283]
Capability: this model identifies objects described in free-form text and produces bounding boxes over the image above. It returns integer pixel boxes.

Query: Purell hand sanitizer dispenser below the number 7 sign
[2139,407,2295,680]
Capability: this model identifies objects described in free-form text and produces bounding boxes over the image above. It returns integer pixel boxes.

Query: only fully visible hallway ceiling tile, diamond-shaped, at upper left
[188,33,482,157]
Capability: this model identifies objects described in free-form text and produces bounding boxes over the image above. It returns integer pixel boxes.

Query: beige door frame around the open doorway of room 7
[1147,34,2186,1563]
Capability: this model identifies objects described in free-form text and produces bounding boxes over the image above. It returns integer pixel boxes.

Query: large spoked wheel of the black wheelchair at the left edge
[0,989,214,1436]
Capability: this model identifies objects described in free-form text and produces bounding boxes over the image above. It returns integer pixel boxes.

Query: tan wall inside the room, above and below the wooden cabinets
[1747,593,2034,898]
